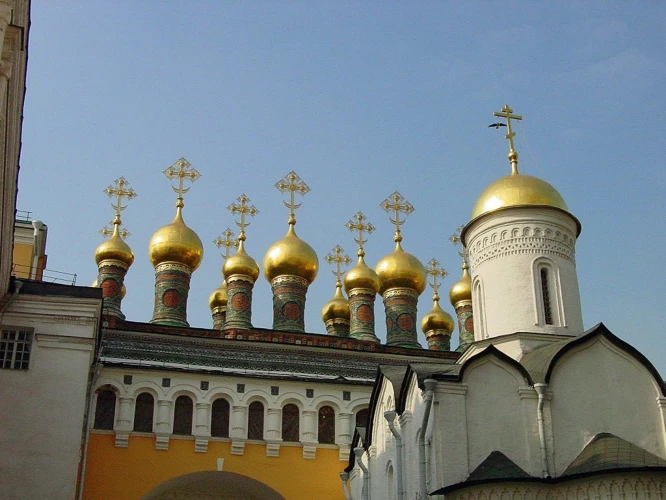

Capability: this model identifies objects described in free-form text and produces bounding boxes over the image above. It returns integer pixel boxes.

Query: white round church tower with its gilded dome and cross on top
[461,105,583,341]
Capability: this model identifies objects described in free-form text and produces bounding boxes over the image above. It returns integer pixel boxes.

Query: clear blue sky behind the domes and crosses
[18,0,666,374]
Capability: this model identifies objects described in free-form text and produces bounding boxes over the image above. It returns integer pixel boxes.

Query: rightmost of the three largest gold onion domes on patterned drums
[375,241,426,295]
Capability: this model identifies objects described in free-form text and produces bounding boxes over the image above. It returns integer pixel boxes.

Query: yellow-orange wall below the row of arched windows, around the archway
[83,433,347,500]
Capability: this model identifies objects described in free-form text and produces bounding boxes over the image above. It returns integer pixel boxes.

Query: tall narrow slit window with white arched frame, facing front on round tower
[532,257,565,326]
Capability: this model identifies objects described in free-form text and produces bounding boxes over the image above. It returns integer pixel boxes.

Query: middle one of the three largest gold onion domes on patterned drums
[264,224,319,283]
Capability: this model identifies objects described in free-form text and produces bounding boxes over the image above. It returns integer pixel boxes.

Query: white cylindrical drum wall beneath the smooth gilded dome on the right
[466,207,583,340]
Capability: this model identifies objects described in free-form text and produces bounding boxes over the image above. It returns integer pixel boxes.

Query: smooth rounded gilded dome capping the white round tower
[472,173,569,219]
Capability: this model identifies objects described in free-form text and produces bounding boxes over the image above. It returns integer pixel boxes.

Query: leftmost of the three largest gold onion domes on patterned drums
[148,207,203,271]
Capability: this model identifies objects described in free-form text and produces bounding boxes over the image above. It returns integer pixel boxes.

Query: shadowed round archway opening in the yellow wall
[141,471,285,500]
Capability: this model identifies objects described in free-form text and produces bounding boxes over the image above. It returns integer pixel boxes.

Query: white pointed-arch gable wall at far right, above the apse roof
[550,336,666,475]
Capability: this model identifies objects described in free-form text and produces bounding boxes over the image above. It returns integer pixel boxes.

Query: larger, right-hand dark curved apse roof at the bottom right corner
[562,432,666,476]
